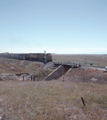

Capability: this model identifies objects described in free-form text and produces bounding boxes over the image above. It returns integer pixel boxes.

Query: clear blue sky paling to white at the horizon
[0,0,107,54]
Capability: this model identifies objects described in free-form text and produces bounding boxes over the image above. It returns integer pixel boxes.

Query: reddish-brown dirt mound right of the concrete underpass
[59,68,107,84]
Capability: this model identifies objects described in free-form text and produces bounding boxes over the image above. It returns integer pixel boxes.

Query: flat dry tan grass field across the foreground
[0,81,107,120]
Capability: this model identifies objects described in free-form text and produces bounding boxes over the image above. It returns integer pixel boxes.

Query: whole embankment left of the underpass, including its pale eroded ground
[0,58,53,81]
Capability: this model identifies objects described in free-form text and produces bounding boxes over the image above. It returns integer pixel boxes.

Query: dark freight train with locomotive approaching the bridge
[0,52,52,63]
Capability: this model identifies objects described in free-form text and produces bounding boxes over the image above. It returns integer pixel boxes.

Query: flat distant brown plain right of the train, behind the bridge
[52,54,107,66]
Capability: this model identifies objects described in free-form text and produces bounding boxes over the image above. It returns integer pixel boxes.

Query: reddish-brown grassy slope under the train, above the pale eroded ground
[0,58,52,80]
